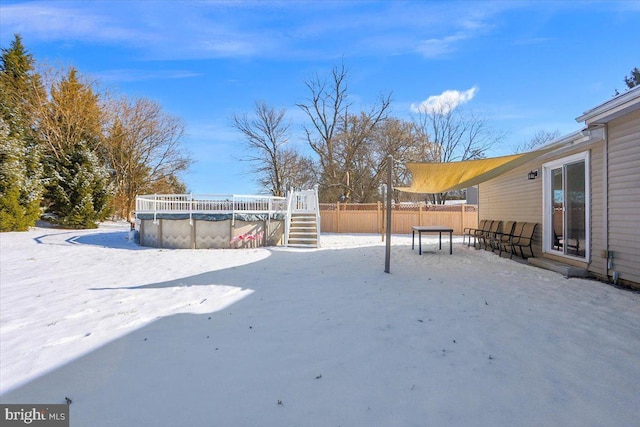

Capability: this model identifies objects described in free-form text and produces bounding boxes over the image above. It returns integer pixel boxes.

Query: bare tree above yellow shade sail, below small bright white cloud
[414,103,504,203]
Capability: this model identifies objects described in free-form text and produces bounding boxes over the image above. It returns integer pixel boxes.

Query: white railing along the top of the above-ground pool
[136,194,287,226]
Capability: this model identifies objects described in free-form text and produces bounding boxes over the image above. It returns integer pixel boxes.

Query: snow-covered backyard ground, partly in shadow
[0,223,640,427]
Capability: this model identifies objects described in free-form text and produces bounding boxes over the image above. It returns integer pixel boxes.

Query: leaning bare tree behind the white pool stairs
[231,101,312,196]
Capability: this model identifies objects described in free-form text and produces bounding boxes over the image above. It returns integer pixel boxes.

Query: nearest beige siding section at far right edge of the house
[608,111,640,283]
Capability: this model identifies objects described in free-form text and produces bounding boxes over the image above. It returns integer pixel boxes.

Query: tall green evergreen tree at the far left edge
[0,35,44,231]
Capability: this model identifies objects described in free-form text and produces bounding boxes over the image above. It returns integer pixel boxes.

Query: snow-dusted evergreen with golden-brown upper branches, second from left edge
[40,68,111,228]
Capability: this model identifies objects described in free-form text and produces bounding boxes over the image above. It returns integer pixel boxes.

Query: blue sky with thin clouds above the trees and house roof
[0,0,640,194]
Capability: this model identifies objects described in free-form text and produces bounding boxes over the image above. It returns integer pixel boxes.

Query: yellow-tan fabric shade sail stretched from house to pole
[396,147,554,193]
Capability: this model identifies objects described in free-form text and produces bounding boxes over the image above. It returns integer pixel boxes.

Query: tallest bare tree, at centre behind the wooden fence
[297,64,391,202]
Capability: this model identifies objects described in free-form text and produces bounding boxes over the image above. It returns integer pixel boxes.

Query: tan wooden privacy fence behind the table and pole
[320,202,478,235]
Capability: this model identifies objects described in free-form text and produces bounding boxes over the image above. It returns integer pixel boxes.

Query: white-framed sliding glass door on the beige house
[542,152,590,260]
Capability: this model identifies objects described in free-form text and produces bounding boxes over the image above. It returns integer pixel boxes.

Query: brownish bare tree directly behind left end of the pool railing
[105,97,192,219]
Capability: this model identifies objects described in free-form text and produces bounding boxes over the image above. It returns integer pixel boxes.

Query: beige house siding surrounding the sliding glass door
[478,88,640,287]
